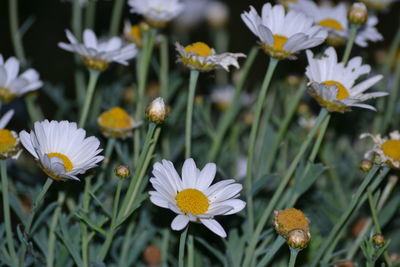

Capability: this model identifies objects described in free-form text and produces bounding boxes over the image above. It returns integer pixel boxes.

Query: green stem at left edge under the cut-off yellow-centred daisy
[0,160,18,265]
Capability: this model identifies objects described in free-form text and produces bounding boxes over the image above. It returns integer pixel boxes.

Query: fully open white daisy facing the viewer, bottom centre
[149,159,246,237]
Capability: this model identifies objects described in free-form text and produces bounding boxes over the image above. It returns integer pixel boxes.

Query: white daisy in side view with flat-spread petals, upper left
[58,29,137,71]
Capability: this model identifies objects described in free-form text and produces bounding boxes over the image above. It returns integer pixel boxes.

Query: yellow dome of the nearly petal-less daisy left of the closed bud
[99,107,132,130]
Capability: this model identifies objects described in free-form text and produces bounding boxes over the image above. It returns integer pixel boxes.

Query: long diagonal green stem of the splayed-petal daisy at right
[243,109,328,266]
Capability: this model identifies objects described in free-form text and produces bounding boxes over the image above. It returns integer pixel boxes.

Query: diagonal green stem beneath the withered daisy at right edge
[311,166,388,267]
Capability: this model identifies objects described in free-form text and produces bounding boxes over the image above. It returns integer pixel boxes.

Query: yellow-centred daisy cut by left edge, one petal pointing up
[0,110,21,159]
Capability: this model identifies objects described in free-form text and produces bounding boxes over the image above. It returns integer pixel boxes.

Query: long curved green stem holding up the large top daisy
[245,58,279,234]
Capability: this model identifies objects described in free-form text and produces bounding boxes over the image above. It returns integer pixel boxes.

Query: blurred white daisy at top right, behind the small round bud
[289,0,382,47]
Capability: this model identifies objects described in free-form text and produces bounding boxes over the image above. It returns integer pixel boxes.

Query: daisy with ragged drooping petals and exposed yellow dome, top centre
[175,42,246,71]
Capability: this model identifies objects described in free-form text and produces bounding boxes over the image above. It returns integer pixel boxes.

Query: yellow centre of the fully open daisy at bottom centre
[175,189,209,215]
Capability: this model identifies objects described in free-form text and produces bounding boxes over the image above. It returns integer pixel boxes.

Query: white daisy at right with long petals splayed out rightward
[306,47,387,113]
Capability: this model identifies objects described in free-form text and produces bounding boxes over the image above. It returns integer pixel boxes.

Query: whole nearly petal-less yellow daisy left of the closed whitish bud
[97,107,141,138]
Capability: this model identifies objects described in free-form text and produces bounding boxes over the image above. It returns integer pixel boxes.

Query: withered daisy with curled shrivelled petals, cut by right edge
[360,131,400,169]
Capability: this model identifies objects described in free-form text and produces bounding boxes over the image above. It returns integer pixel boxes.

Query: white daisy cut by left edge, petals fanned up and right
[0,54,43,102]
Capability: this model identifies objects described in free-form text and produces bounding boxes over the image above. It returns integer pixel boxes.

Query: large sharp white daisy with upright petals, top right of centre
[241,3,327,59]
